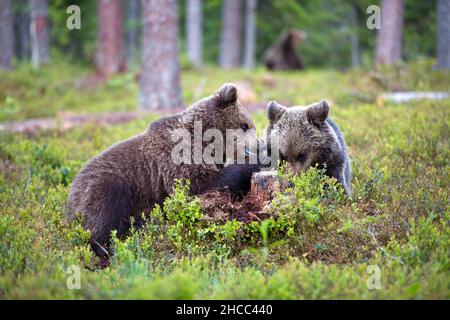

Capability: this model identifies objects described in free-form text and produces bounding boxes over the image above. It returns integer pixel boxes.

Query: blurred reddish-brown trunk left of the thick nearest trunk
[96,0,126,78]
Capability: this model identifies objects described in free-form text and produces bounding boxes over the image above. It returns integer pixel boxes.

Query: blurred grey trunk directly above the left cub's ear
[219,0,242,69]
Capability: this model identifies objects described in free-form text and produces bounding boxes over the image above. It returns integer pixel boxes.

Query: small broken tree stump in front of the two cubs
[250,171,280,208]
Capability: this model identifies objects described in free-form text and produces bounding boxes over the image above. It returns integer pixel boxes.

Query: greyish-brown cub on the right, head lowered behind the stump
[266,100,351,195]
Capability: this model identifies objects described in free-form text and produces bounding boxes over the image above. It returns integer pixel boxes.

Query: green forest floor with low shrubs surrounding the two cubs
[0,61,450,299]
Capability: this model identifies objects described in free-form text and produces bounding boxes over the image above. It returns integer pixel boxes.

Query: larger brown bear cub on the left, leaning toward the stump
[66,84,255,255]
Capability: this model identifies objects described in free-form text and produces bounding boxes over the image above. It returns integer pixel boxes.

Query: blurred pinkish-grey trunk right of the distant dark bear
[375,0,404,64]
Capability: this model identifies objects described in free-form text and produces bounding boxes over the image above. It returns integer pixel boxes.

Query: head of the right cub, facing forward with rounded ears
[266,100,338,173]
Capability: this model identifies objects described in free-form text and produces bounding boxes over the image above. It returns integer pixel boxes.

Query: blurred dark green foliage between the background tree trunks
[14,0,436,68]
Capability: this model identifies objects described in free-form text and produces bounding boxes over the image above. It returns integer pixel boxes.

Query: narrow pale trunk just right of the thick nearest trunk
[186,0,203,68]
